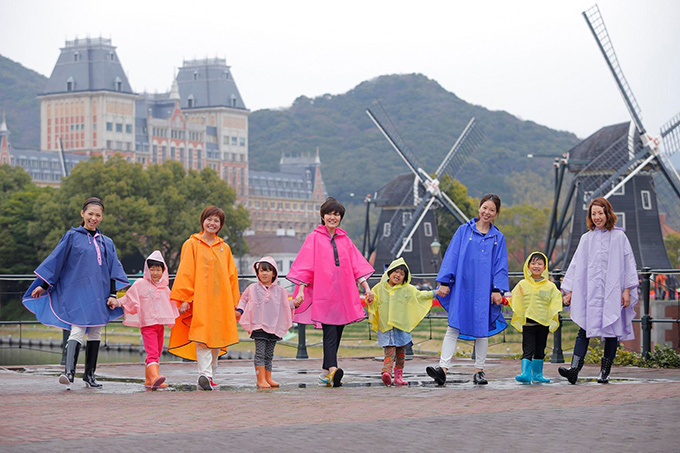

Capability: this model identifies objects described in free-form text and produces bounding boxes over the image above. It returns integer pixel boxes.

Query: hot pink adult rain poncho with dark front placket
[286,225,373,327]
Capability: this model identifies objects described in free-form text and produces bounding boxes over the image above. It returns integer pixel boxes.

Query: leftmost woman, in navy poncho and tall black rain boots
[23,197,128,388]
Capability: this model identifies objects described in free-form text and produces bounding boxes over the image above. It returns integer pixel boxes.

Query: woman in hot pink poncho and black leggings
[286,197,373,387]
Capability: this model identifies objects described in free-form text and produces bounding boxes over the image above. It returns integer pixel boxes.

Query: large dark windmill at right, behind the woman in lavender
[547,5,680,269]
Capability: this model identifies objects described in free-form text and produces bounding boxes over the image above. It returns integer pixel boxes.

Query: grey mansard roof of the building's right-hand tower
[177,58,246,110]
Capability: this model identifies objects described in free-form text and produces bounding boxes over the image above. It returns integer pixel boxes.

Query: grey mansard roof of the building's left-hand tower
[42,38,134,95]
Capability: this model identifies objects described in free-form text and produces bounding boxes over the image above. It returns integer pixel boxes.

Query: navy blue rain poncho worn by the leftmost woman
[23,226,129,330]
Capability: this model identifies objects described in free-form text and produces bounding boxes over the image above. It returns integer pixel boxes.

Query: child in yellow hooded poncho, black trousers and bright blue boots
[510,252,562,384]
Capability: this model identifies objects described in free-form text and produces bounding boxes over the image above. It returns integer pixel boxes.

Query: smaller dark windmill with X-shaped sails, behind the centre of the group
[364,102,483,273]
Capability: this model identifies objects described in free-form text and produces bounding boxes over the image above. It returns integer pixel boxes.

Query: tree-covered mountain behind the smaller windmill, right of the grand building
[249,74,579,206]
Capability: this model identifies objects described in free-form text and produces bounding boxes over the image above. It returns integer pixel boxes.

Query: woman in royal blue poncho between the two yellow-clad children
[426,194,510,385]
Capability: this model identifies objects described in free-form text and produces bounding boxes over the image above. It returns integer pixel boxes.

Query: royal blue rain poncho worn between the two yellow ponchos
[437,219,510,340]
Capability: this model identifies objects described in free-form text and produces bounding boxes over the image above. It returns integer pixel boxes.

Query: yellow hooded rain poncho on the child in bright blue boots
[510,252,562,332]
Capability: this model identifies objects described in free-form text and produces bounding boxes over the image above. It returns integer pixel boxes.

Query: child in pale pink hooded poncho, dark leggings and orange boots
[236,256,295,388]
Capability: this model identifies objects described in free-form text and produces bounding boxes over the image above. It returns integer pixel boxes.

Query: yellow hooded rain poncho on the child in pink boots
[368,258,434,332]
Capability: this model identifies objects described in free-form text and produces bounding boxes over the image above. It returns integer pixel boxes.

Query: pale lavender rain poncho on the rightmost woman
[562,227,639,341]
